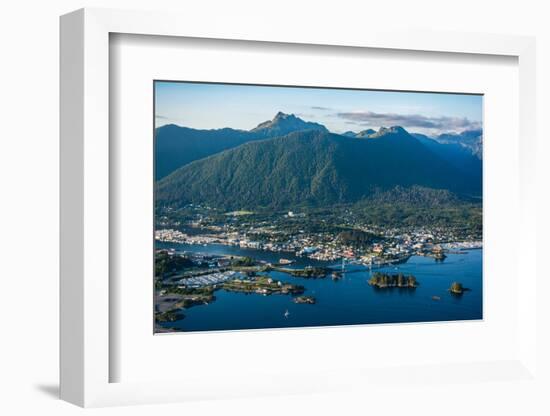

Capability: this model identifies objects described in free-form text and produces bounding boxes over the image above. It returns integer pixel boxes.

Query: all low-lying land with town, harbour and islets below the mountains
[155,206,482,328]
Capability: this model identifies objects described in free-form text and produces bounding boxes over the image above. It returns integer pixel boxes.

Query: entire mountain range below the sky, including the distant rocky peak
[155,113,482,209]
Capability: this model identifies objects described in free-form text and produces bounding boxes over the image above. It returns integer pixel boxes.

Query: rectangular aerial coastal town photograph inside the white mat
[151,80,483,333]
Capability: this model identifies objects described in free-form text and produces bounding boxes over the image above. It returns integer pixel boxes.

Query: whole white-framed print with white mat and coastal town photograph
[60,9,541,412]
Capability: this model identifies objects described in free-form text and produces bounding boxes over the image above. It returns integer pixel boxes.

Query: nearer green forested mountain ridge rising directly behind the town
[156,127,481,209]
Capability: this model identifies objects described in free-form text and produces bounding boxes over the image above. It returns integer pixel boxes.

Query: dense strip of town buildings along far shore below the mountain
[155,204,482,266]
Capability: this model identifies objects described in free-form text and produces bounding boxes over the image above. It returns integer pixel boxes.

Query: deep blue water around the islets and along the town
[157,243,483,331]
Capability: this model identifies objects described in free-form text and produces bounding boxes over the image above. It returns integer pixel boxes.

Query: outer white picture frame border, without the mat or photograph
[60,9,539,407]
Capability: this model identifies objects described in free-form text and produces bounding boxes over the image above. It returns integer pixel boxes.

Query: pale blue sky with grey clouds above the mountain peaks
[155,81,483,135]
